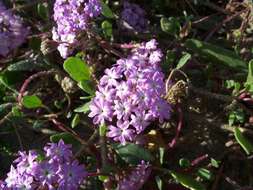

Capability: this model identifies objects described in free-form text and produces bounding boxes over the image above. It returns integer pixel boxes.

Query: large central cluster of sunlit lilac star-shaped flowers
[89,40,171,144]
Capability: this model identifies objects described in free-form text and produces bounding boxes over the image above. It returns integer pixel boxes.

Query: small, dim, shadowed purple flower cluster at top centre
[121,1,148,32]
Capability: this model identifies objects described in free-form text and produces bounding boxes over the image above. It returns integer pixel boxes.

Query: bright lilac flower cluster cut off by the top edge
[52,0,102,58]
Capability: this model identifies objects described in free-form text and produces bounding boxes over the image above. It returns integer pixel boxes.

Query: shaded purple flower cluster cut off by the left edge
[0,2,29,57]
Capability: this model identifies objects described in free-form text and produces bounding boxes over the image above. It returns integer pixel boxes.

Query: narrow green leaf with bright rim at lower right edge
[234,127,253,155]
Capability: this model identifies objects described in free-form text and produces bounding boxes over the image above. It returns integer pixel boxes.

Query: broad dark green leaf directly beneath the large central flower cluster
[112,143,154,165]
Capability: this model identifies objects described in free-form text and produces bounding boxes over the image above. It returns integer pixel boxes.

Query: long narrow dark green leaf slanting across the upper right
[185,39,247,72]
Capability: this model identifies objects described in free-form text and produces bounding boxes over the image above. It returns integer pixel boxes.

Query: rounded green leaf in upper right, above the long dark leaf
[160,17,180,35]
